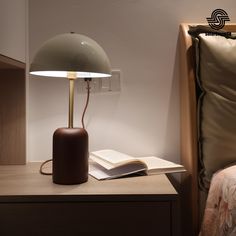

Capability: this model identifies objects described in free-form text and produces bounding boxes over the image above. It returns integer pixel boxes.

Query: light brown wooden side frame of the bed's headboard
[179,23,236,236]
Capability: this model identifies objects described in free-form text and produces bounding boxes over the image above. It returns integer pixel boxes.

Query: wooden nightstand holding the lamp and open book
[0,163,178,236]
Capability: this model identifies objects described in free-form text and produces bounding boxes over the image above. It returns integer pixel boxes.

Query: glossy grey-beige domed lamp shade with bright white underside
[30,33,111,78]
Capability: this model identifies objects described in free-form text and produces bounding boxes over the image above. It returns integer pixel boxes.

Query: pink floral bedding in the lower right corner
[199,165,236,236]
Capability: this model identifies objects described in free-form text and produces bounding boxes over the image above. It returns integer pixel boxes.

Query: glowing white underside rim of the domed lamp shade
[30,71,111,78]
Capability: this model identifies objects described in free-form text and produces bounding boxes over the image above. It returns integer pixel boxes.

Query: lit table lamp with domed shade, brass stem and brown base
[30,33,111,184]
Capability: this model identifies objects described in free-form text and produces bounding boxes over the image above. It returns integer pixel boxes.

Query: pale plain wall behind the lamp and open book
[28,0,236,162]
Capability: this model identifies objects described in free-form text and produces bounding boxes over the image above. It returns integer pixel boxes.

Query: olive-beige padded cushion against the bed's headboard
[192,31,236,189]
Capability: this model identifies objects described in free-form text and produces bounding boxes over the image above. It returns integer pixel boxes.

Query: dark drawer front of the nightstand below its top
[0,201,171,236]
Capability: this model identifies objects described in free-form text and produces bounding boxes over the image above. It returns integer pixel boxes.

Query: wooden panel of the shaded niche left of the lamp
[0,56,26,164]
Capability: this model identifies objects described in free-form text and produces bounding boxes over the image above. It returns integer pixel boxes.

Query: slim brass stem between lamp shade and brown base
[67,72,76,128]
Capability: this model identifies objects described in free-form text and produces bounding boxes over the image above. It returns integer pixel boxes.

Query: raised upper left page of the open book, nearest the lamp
[91,149,135,165]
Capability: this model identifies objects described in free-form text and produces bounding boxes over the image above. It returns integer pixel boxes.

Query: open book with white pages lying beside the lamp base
[89,149,185,180]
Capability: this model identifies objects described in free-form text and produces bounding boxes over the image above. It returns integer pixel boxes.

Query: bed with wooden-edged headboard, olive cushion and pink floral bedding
[179,24,236,236]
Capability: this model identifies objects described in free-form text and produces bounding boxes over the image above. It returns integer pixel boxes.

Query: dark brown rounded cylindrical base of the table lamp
[52,128,89,184]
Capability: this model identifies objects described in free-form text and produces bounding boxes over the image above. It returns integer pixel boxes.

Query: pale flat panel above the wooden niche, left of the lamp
[0,0,28,62]
